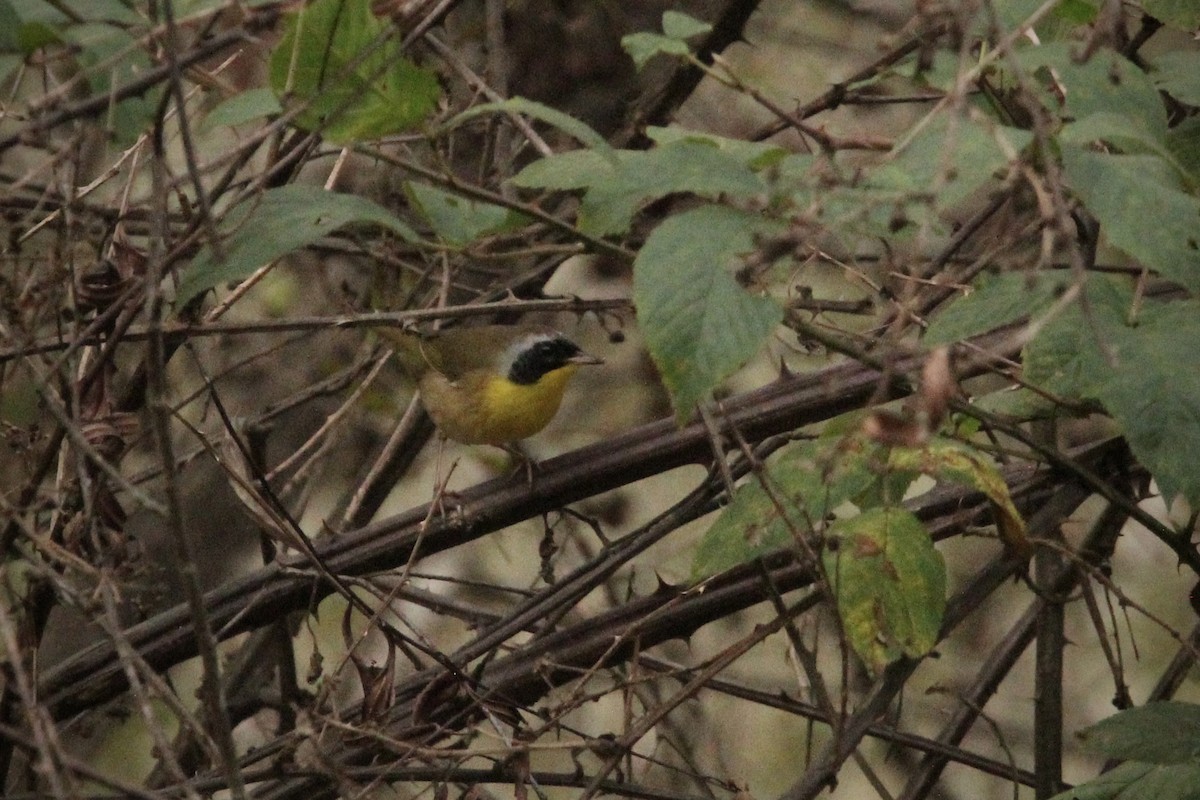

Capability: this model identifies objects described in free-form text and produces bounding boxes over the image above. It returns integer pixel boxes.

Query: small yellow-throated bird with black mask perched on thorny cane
[378,325,604,445]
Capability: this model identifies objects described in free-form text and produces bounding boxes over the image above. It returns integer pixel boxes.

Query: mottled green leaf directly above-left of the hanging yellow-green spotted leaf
[691,443,878,579]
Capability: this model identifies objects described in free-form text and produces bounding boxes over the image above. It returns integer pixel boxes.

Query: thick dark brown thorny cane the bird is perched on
[41,326,1022,716]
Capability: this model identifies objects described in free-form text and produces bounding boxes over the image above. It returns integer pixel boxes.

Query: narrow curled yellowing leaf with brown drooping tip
[888,438,1033,559]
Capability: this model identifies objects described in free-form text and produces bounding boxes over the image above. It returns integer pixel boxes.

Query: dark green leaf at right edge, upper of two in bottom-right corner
[1079,702,1200,767]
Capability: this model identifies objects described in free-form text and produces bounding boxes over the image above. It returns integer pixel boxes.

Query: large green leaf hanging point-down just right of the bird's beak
[634,206,782,422]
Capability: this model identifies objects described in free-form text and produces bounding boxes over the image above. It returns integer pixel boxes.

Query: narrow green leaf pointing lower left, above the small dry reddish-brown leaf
[922,272,1070,347]
